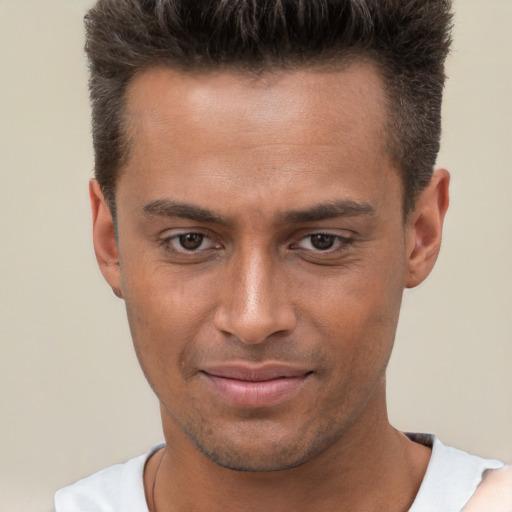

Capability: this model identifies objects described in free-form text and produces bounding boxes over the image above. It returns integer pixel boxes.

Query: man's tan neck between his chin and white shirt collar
[145,389,430,512]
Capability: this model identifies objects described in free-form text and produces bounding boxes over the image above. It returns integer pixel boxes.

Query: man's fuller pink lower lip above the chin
[203,373,310,407]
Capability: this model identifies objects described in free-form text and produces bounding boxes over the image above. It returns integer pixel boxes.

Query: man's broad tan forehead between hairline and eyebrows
[118,62,396,218]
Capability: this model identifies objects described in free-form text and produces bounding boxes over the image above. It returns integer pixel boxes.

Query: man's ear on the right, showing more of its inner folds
[406,169,450,288]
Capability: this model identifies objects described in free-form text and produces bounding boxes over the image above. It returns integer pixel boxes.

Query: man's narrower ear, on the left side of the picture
[89,179,122,298]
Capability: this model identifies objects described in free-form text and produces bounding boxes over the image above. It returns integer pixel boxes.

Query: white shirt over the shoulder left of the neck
[55,445,162,512]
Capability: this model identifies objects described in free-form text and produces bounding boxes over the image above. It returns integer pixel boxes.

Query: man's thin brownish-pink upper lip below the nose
[201,364,311,382]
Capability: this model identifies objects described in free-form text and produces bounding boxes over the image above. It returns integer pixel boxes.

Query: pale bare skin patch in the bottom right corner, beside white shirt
[464,466,512,512]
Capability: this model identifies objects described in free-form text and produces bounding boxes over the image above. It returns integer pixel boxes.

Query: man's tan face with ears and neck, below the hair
[91,62,449,512]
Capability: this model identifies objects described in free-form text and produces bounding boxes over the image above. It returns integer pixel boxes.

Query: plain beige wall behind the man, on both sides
[0,0,512,512]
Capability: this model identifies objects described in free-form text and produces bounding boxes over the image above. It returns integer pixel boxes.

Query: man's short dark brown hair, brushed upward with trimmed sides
[85,0,452,212]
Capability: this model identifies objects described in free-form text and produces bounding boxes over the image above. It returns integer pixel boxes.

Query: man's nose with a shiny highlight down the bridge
[214,251,296,344]
